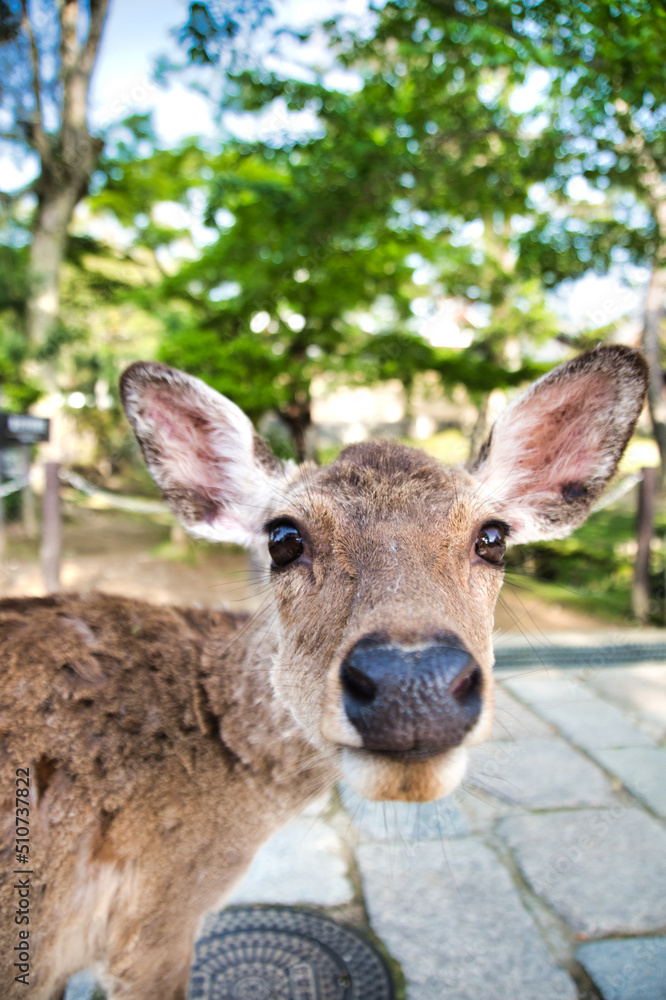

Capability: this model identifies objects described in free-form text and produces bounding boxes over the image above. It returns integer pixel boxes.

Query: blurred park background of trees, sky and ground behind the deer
[0,0,666,634]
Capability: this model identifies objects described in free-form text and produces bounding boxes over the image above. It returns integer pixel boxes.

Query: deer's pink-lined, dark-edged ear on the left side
[120,361,284,545]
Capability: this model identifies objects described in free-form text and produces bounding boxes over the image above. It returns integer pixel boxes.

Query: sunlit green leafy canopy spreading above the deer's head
[8,0,664,474]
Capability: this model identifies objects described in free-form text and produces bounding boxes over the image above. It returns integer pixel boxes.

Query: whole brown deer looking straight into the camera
[0,346,647,1000]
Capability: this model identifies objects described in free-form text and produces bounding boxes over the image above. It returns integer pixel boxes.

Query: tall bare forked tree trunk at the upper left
[0,0,108,354]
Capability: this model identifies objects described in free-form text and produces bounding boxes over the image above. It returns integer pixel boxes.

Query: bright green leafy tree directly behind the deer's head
[85,123,430,455]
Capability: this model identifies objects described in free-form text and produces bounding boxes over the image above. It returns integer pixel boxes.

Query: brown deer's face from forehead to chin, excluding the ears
[267,450,503,799]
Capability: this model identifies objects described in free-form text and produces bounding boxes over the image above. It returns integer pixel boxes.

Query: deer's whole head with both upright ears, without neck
[122,348,646,801]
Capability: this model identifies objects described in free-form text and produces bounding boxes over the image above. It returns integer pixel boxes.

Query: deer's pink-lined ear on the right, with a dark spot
[471,345,648,542]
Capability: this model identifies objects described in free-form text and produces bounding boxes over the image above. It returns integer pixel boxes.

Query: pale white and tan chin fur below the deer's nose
[342,747,467,802]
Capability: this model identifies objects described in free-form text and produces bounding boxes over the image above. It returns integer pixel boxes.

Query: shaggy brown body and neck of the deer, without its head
[0,594,338,998]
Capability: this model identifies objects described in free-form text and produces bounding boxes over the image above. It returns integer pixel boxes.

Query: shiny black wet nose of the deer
[340,635,482,756]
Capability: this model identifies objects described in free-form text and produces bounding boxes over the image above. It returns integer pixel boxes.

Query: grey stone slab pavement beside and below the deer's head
[63,647,666,1000]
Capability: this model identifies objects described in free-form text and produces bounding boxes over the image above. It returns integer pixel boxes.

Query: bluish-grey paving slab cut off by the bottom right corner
[576,938,666,1000]
